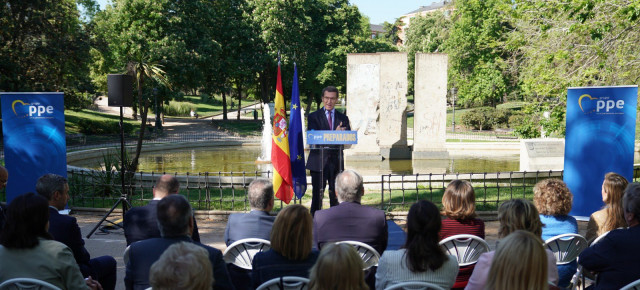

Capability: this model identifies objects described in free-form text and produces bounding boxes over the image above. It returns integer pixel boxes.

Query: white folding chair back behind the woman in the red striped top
[440,235,490,267]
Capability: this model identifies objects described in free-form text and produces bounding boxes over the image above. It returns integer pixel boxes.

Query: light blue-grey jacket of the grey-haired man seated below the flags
[224,210,276,246]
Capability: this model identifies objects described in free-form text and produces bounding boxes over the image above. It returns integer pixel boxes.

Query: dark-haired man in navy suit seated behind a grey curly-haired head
[124,194,234,289]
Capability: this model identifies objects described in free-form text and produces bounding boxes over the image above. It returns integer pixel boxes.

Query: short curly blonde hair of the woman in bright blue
[533,178,573,215]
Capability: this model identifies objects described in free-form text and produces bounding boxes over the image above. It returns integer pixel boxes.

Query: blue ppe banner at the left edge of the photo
[0,93,67,202]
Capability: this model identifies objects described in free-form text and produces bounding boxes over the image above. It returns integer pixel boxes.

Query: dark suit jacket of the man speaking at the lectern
[307,107,351,171]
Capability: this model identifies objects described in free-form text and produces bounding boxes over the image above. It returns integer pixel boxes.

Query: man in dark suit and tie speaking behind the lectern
[307,86,351,215]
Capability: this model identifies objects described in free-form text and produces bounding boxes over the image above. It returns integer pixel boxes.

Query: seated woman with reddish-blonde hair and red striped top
[440,180,484,289]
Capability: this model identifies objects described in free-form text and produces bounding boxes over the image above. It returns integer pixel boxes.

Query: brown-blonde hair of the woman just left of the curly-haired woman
[498,198,543,238]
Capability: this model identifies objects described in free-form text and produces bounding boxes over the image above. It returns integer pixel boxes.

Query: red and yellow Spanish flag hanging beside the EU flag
[271,62,293,204]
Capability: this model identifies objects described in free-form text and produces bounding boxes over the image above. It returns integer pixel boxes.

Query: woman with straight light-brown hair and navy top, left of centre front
[251,204,318,288]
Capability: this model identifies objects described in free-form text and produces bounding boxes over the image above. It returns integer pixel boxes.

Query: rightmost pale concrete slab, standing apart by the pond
[412,53,449,159]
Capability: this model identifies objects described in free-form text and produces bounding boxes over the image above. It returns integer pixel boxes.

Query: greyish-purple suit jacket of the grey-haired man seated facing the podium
[313,202,388,255]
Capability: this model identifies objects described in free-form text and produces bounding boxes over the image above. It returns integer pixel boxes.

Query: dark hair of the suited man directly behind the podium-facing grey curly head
[158,194,193,237]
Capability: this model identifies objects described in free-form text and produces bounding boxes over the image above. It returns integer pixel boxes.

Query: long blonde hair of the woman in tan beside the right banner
[602,172,629,233]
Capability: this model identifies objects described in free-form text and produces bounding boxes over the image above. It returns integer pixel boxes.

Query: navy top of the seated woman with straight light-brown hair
[251,249,319,289]
